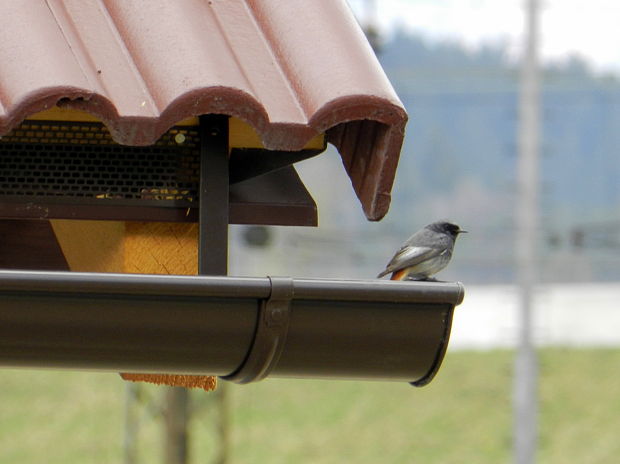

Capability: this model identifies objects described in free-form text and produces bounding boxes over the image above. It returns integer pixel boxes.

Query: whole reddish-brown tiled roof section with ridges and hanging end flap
[0,0,407,220]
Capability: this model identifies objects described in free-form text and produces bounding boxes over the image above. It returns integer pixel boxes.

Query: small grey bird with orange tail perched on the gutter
[377,221,467,280]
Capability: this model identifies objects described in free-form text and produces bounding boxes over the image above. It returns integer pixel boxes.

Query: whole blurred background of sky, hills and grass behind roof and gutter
[0,0,620,464]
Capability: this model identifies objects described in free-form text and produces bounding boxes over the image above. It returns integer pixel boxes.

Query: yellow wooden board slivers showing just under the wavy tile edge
[28,106,325,150]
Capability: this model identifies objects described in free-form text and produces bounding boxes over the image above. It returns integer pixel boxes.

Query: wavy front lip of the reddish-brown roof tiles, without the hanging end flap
[0,87,407,155]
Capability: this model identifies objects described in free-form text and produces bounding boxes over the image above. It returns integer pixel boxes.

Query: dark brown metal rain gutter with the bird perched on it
[0,271,464,386]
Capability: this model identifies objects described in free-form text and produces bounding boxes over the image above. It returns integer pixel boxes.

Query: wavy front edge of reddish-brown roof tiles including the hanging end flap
[0,91,408,221]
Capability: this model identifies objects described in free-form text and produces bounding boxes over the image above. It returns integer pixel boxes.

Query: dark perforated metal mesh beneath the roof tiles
[0,121,200,207]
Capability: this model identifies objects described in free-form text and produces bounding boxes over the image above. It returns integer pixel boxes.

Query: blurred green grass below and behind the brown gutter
[0,349,620,464]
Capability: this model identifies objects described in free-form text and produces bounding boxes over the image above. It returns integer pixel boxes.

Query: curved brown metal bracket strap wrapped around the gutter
[221,277,294,384]
